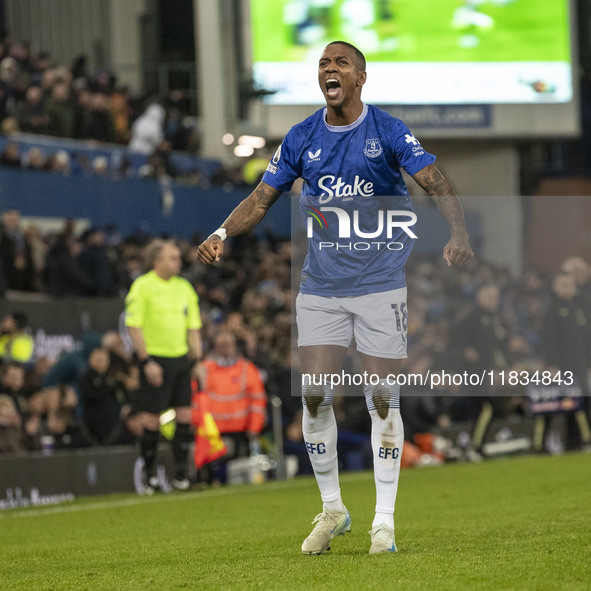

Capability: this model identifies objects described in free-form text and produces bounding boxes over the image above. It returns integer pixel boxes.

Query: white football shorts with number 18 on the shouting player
[296,287,408,359]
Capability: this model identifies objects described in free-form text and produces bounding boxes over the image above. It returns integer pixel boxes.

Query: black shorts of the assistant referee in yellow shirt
[133,355,191,414]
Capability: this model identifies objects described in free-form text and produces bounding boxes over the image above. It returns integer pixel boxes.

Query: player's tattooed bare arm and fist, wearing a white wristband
[197,182,281,265]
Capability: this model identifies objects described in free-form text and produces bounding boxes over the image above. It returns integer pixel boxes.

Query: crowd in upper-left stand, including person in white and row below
[0,40,231,183]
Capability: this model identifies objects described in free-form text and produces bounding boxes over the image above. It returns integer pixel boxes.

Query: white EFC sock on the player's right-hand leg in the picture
[363,380,404,529]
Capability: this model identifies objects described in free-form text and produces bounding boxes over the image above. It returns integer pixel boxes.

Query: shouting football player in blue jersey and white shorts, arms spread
[198,41,473,554]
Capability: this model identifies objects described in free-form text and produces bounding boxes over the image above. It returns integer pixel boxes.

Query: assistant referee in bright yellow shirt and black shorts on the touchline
[125,239,202,494]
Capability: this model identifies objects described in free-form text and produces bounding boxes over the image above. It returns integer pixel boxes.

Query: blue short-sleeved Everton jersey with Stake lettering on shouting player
[262,104,435,297]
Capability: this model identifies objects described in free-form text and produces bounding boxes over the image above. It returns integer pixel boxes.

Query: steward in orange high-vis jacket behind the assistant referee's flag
[200,332,267,435]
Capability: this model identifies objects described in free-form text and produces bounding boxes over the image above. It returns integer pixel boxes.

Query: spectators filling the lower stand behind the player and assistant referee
[0,198,591,464]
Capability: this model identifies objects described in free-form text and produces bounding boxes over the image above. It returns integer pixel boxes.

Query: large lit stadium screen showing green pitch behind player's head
[250,0,573,105]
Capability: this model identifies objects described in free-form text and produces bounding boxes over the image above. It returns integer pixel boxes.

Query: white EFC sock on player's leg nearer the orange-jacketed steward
[302,385,344,511]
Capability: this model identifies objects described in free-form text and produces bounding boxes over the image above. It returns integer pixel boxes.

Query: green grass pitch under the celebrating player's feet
[0,454,591,591]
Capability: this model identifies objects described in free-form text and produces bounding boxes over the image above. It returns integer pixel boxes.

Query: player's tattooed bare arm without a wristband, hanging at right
[413,164,474,266]
